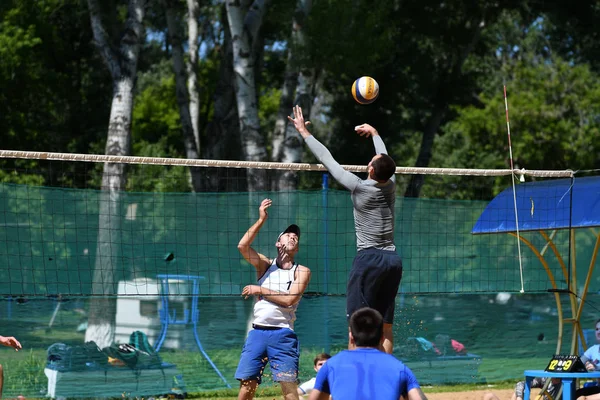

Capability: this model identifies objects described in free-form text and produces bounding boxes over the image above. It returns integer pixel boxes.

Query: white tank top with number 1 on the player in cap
[254,260,298,330]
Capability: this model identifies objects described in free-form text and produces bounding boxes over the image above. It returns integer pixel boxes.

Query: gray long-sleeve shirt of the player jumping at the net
[304,135,396,251]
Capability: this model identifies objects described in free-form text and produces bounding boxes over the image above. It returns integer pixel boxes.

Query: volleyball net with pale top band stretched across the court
[0,151,570,297]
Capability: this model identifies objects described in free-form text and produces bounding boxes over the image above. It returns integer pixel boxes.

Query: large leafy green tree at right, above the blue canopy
[422,12,600,199]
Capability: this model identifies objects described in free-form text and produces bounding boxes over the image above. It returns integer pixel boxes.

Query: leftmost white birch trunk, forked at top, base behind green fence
[85,0,145,348]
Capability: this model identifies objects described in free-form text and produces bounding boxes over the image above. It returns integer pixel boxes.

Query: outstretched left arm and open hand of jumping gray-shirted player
[288,106,360,191]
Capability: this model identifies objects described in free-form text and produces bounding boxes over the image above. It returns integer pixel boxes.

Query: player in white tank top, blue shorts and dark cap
[235,199,310,399]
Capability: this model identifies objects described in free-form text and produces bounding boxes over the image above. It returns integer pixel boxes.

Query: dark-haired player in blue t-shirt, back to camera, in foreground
[310,307,427,400]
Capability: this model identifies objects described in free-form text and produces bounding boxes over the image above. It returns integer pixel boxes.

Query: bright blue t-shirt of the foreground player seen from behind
[315,348,420,400]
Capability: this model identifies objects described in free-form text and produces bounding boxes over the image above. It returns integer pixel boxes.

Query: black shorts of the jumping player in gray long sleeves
[346,249,402,324]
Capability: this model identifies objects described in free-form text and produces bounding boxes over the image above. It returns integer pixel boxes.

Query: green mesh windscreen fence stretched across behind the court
[0,174,600,398]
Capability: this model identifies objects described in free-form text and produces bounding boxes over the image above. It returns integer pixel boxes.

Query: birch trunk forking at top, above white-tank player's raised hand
[226,0,268,192]
